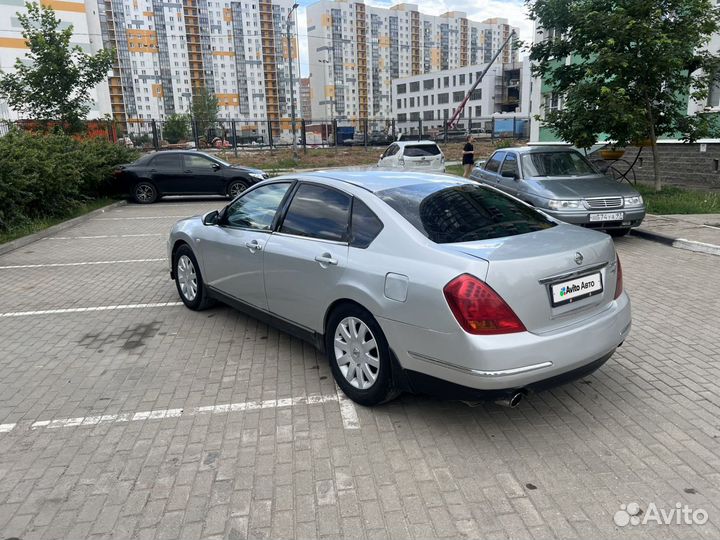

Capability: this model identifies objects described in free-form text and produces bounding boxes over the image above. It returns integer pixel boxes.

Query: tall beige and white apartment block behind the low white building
[307,0,518,121]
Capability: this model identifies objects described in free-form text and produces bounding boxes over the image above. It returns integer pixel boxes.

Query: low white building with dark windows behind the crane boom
[392,60,531,134]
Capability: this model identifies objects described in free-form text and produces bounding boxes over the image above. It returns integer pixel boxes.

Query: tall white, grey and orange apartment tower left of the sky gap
[98,0,299,136]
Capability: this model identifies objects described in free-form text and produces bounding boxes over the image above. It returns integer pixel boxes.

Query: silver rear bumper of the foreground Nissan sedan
[379,294,631,394]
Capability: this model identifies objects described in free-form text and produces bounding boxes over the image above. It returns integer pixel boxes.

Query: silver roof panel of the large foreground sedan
[303,169,476,193]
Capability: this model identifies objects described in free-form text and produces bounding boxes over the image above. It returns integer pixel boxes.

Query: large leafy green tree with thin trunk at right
[526,0,720,191]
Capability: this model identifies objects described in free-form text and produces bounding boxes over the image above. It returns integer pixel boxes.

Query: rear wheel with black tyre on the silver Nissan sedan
[325,304,398,406]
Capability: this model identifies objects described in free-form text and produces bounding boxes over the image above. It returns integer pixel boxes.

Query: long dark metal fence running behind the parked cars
[0,117,529,153]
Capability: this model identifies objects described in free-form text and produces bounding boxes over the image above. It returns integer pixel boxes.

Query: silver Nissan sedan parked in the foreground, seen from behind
[168,171,630,405]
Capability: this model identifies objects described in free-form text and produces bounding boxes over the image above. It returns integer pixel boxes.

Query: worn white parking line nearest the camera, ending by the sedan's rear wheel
[0,393,360,433]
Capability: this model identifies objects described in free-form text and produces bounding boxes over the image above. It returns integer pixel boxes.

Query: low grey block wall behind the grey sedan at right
[590,142,720,190]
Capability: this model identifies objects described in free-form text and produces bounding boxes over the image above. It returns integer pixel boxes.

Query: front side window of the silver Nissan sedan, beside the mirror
[223,182,290,231]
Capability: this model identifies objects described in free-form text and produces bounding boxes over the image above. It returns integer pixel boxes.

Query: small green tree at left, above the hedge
[0,3,112,131]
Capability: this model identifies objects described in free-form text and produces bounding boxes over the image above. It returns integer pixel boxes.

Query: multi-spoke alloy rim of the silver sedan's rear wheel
[334,317,380,390]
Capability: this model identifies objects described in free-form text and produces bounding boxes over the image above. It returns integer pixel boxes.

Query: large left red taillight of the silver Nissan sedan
[443,274,525,335]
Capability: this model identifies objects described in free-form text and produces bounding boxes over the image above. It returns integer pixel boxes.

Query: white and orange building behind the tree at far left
[0,0,111,120]
